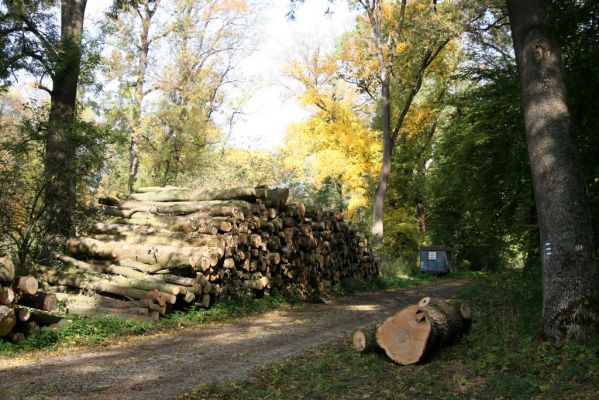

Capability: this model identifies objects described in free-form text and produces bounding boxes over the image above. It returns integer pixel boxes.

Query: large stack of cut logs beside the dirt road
[39,187,378,319]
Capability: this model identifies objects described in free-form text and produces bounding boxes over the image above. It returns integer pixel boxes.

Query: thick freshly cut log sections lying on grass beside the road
[353,297,472,365]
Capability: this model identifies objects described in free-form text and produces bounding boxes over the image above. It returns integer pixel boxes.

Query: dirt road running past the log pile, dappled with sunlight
[0,279,470,400]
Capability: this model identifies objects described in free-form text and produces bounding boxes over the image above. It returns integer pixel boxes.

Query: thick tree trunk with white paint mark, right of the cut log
[507,0,599,342]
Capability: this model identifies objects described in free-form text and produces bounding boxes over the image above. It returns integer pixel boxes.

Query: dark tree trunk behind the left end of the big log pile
[45,0,86,244]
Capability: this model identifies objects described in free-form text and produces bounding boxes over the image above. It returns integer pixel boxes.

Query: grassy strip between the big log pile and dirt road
[0,277,446,357]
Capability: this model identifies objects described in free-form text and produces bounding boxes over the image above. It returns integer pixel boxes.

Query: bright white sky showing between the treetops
[86,0,355,150]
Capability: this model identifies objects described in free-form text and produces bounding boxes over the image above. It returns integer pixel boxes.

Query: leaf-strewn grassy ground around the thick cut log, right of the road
[179,271,599,400]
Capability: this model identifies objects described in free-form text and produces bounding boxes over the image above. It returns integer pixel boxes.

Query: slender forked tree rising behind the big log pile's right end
[344,0,455,244]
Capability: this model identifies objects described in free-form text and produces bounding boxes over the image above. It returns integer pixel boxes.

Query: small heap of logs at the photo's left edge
[0,257,61,344]
